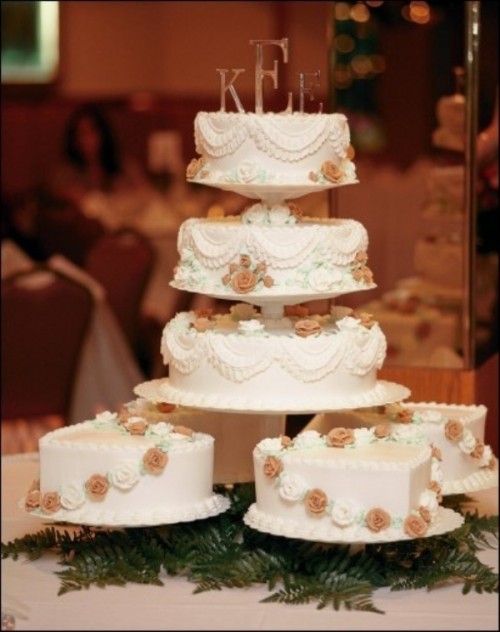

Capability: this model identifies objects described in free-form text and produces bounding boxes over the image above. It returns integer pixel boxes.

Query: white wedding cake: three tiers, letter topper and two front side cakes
[22,40,492,542]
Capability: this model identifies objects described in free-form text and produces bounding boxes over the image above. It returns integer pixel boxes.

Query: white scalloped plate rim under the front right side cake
[243,503,464,544]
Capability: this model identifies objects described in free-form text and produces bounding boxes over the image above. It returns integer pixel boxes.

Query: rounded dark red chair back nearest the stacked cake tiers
[85,228,155,350]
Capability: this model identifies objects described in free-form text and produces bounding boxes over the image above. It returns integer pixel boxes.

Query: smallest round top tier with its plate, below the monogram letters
[186,111,357,201]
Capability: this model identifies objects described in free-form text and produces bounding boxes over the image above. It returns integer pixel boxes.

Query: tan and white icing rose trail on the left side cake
[24,409,193,514]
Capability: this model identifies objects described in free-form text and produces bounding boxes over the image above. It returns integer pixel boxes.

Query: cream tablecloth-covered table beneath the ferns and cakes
[2,454,499,631]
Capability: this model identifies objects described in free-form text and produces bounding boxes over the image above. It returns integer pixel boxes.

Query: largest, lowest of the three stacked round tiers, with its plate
[135,303,409,413]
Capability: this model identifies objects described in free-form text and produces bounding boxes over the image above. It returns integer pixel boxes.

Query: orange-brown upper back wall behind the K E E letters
[59,1,329,103]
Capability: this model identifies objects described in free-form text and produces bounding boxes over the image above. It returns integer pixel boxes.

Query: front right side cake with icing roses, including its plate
[244,425,463,543]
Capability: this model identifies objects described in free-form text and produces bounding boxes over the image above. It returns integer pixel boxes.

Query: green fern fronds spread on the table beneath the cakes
[2,484,498,614]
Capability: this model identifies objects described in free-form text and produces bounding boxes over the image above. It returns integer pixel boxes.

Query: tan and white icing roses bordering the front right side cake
[257,424,442,538]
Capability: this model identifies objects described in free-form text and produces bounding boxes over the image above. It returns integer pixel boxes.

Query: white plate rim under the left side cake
[19,494,230,528]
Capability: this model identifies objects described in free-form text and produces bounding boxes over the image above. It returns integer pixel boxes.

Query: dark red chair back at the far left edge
[1,266,94,420]
